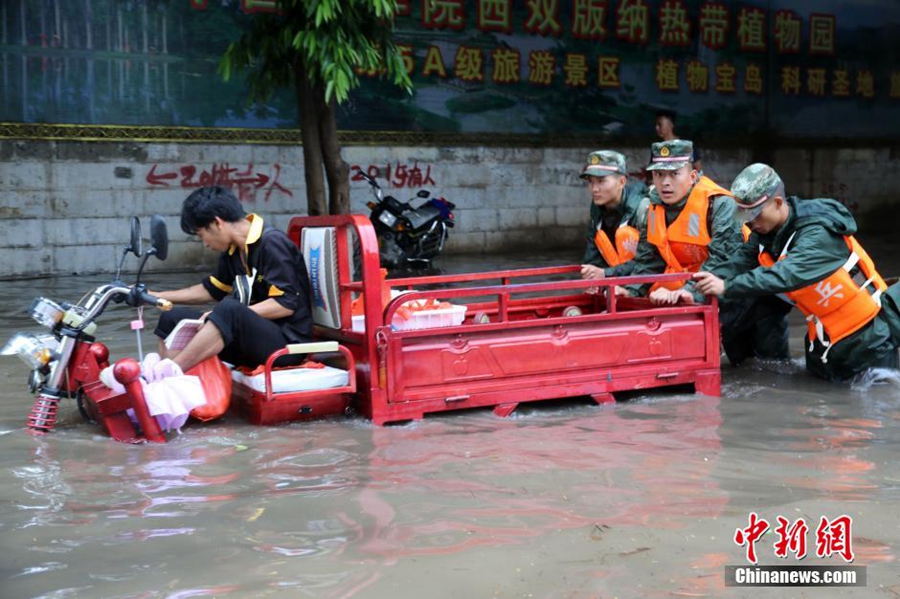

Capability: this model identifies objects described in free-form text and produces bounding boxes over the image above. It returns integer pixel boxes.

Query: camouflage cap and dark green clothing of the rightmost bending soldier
[723,164,900,380]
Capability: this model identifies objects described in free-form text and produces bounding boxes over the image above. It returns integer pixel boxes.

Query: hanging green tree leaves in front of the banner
[219,0,412,103]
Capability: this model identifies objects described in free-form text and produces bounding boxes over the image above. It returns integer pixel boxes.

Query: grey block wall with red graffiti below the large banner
[0,140,897,278]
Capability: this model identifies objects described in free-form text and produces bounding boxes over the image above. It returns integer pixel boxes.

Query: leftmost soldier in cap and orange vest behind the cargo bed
[581,150,649,279]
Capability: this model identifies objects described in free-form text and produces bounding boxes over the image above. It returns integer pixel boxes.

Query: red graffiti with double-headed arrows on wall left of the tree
[147,162,294,202]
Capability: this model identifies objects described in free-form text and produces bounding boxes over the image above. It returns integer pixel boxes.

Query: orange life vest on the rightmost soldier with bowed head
[759,235,887,362]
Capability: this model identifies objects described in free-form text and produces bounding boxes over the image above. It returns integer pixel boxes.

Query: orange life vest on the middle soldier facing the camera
[647,177,734,291]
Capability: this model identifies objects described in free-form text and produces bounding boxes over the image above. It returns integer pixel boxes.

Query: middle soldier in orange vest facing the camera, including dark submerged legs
[626,139,789,364]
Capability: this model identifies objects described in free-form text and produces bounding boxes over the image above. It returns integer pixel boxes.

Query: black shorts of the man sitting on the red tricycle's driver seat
[153,297,303,368]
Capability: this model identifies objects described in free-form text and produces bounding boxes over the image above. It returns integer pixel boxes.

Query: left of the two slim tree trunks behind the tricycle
[294,64,328,216]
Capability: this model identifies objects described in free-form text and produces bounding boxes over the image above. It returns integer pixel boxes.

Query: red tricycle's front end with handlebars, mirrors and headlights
[0,215,172,443]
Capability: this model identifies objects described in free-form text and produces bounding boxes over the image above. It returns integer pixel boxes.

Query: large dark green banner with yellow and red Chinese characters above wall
[0,0,900,139]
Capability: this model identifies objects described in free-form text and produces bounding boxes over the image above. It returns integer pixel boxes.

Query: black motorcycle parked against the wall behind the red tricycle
[359,169,456,268]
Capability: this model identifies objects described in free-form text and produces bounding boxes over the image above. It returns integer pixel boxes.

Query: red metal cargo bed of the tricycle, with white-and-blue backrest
[289,215,720,424]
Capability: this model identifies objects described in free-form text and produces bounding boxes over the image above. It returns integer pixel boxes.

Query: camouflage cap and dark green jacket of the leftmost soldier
[580,150,649,276]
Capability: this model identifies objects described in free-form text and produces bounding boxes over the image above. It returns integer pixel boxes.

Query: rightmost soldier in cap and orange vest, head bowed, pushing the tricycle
[694,164,900,380]
